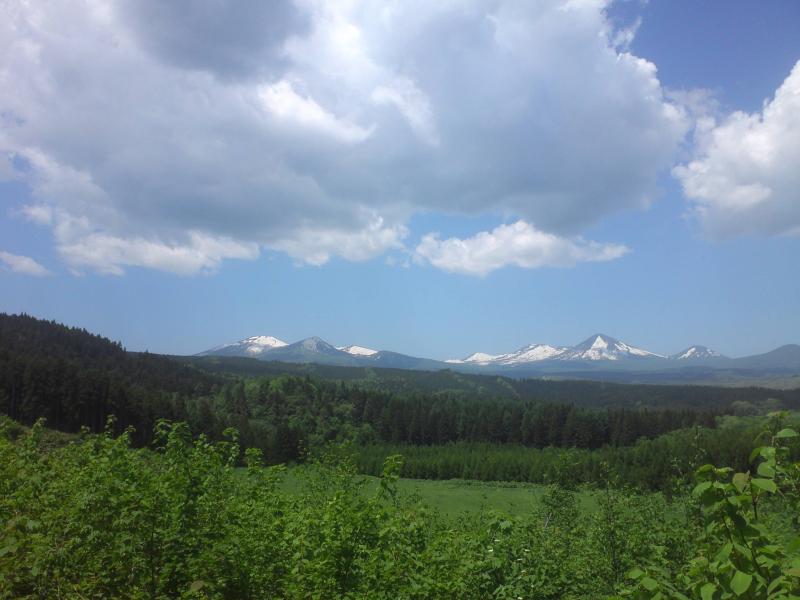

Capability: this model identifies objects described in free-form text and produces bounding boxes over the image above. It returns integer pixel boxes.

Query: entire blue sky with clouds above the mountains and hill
[0,0,800,359]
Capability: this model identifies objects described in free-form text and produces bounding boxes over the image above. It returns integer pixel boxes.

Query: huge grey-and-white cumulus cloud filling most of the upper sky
[0,0,686,273]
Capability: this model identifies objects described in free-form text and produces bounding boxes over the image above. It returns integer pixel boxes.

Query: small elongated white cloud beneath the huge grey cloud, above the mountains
[416,221,628,275]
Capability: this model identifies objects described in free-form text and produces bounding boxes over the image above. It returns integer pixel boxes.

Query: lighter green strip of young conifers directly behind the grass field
[356,427,759,492]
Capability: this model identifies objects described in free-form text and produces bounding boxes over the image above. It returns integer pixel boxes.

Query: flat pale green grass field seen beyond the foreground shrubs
[283,467,597,517]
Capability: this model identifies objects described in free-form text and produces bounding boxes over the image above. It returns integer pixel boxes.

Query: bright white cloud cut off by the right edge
[673,62,800,238]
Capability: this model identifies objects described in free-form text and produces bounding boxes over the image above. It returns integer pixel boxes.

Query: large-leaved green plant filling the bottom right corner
[629,413,800,600]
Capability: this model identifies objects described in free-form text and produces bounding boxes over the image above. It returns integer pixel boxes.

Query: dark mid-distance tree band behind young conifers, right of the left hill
[161,376,717,462]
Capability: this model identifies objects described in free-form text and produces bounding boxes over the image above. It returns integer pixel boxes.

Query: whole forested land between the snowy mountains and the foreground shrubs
[0,315,798,487]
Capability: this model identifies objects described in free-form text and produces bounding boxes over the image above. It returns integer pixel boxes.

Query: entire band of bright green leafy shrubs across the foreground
[0,414,800,599]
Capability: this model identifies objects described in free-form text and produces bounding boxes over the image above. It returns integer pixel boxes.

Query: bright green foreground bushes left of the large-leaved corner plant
[0,421,696,598]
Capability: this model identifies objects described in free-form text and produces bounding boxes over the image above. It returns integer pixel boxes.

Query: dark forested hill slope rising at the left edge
[0,314,222,441]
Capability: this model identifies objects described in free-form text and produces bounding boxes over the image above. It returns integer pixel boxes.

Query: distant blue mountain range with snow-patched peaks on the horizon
[198,333,800,378]
